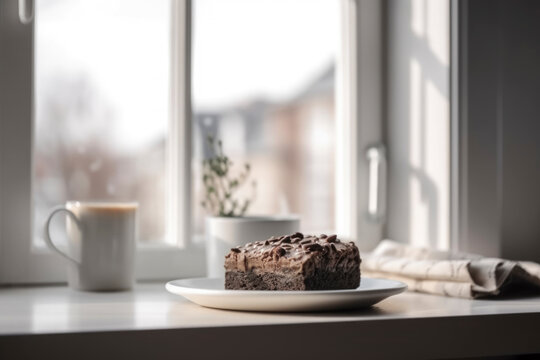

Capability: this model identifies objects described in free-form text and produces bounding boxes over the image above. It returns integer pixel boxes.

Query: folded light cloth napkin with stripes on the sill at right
[362,240,540,298]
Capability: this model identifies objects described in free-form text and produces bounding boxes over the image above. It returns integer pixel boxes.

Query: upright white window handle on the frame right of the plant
[366,144,387,223]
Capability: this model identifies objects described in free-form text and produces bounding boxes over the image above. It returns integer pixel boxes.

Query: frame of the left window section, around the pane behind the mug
[0,0,205,284]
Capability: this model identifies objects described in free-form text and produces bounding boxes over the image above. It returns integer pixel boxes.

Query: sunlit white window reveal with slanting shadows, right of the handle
[386,0,450,249]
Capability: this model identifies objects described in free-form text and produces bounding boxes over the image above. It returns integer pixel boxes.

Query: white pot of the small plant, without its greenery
[205,216,300,277]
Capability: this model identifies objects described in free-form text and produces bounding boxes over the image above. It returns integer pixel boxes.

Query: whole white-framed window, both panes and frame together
[0,0,380,283]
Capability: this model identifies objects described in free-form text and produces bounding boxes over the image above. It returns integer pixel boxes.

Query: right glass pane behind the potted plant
[192,0,339,233]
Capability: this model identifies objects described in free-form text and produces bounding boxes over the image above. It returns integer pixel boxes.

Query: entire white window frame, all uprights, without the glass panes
[0,0,383,284]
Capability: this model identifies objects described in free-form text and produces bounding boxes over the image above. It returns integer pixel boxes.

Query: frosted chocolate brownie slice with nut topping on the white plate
[225,233,360,290]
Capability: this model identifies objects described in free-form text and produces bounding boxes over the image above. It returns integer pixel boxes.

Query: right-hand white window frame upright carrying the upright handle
[335,0,386,251]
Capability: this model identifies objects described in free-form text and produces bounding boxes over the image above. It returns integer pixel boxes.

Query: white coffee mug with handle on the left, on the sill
[44,201,138,291]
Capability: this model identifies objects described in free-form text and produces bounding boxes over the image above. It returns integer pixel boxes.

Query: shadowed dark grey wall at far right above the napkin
[458,0,540,262]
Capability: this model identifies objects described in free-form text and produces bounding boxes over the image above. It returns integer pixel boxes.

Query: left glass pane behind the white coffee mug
[34,0,170,245]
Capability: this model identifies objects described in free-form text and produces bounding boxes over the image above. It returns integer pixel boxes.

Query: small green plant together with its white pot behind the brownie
[201,136,300,277]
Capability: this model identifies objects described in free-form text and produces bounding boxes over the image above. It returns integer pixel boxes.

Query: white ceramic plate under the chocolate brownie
[165,278,407,312]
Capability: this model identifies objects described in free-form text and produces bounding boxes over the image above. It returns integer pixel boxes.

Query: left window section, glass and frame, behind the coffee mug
[0,0,199,283]
